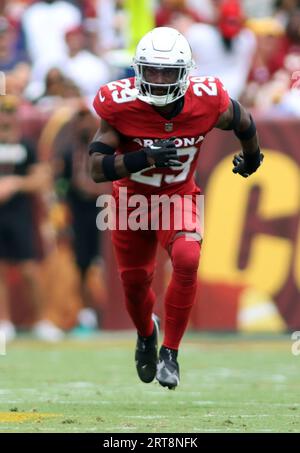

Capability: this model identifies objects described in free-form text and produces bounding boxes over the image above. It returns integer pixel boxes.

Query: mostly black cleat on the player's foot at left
[135,315,159,383]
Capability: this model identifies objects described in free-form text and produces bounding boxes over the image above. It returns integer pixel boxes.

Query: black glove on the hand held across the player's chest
[144,138,181,168]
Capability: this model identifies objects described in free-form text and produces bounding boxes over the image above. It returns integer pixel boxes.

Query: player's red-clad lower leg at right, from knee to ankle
[163,236,200,350]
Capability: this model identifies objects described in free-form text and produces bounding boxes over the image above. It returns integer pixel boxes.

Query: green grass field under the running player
[0,333,300,433]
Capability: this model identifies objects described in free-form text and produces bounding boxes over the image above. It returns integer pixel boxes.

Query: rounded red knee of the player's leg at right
[171,236,200,277]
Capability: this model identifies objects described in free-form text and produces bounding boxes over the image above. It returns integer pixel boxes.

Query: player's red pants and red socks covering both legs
[112,187,200,350]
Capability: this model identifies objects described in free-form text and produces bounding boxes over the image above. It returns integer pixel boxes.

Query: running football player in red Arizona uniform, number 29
[89,27,263,389]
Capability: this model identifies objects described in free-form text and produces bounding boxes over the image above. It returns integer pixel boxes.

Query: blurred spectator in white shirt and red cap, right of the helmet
[171,0,256,99]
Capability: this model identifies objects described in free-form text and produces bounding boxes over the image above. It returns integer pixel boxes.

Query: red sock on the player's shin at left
[121,269,155,337]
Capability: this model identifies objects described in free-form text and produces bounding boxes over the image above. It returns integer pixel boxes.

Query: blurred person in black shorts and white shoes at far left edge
[0,96,63,341]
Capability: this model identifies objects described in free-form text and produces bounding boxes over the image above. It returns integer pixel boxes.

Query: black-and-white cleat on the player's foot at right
[156,346,179,390]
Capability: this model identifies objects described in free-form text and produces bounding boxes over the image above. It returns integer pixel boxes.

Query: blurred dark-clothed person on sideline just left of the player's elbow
[58,105,110,327]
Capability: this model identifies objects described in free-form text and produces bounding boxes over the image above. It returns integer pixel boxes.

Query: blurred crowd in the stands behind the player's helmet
[0,0,300,114]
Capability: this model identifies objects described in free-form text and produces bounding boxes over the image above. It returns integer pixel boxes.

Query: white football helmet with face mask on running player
[133,27,194,106]
